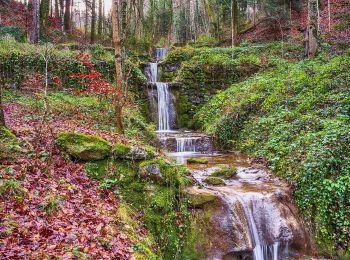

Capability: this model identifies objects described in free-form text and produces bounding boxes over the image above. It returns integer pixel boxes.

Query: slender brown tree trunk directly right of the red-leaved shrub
[112,0,124,133]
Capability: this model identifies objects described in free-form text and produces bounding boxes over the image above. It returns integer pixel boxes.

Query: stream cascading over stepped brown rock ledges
[145,48,313,260]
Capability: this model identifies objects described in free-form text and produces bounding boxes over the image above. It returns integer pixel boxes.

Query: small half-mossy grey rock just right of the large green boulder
[113,144,156,161]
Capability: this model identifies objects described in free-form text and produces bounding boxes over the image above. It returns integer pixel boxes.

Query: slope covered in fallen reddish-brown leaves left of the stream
[0,92,144,259]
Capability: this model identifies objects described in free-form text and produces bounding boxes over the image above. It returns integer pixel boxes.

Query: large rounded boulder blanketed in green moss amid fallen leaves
[57,132,111,161]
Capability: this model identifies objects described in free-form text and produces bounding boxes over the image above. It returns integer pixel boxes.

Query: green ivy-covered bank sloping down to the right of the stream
[195,52,350,256]
